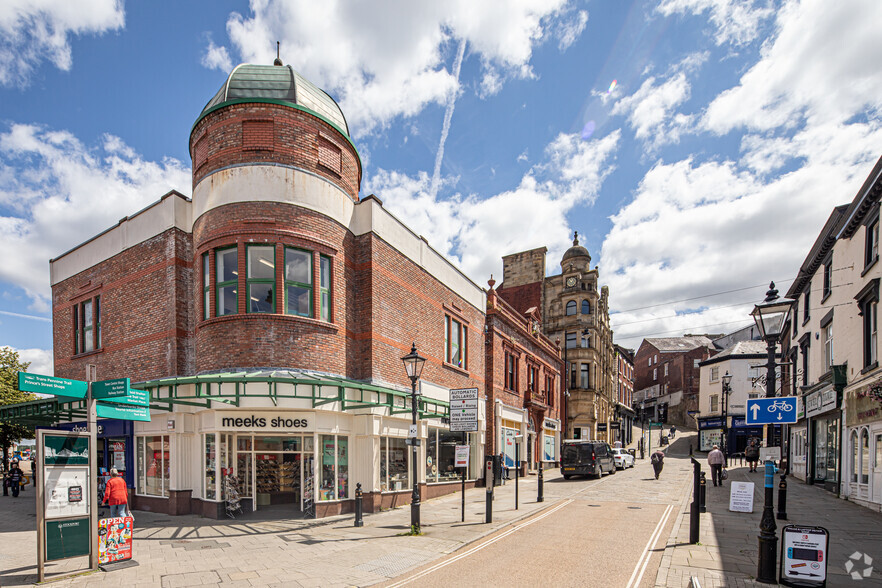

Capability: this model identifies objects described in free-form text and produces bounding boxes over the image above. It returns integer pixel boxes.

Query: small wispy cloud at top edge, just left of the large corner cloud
[656,0,772,45]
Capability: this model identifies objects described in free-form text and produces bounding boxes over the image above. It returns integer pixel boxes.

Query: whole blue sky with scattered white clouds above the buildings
[0,0,882,374]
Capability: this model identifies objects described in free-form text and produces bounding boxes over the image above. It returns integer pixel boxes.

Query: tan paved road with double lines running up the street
[386,432,691,588]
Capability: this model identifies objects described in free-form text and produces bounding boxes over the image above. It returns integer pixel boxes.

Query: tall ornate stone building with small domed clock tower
[497,234,621,441]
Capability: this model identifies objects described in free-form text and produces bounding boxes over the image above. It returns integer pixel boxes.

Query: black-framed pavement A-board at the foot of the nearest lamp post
[780,525,830,586]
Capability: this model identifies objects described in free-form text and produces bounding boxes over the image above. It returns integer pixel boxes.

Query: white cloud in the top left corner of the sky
[0,0,125,86]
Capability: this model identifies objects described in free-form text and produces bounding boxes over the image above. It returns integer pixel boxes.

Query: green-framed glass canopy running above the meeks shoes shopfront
[0,370,450,425]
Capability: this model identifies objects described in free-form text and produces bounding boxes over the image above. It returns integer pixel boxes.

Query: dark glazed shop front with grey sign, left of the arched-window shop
[805,385,842,493]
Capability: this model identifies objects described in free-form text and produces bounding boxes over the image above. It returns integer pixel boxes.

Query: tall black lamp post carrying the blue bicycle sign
[750,282,794,584]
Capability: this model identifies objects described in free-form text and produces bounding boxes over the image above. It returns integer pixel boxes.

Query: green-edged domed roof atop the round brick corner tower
[193,63,349,138]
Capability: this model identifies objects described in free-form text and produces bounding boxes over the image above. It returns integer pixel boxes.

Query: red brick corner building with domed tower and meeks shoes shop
[51,60,496,517]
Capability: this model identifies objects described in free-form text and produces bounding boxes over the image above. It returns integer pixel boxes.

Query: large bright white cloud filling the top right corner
[704,0,882,134]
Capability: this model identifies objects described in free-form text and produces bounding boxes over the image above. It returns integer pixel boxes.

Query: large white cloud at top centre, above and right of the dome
[215,0,584,132]
